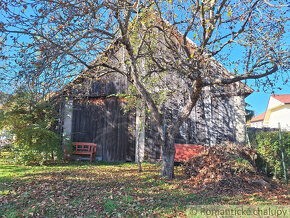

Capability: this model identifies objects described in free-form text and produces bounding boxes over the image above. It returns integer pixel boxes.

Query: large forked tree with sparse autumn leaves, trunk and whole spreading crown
[0,0,289,179]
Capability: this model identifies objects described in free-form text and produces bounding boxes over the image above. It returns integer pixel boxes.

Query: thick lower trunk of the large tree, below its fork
[161,138,175,180]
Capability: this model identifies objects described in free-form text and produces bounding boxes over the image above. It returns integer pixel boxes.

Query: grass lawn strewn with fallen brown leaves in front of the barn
[0,159,289,217]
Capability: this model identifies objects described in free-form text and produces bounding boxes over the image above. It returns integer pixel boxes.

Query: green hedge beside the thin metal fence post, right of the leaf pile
[250,131,290,178]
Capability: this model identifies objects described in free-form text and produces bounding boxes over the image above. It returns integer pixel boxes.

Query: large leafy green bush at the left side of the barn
[0,89,62,165]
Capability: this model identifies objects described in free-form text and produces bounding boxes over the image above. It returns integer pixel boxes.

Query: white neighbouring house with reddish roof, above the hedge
[250,94,290,131]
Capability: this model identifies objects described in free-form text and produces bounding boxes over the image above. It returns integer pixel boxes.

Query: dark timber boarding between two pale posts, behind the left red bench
[72,97,135,161]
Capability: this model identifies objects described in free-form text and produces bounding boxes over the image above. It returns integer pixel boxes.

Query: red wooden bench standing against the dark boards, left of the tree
[69,142,97,161]
